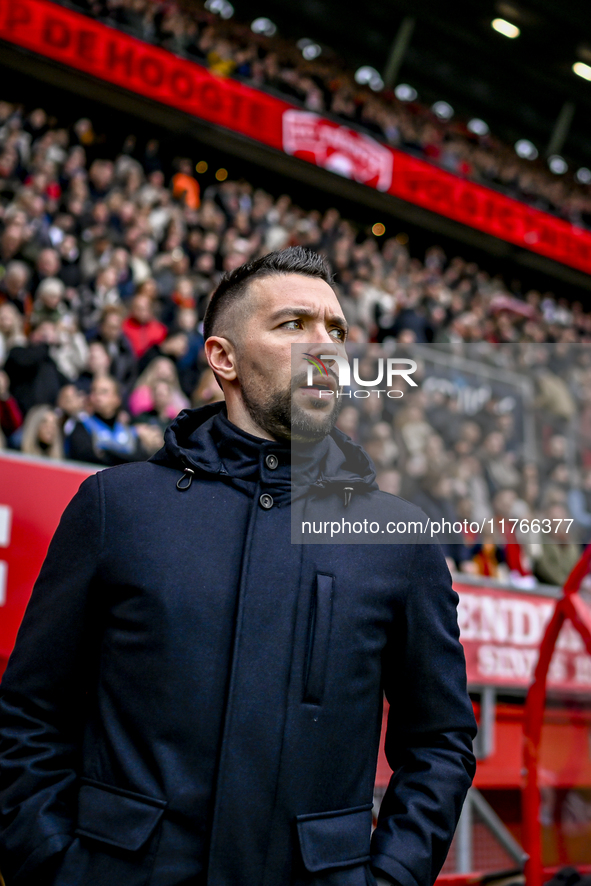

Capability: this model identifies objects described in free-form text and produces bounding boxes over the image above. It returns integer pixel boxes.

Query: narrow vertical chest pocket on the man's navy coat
[304,572,334,705]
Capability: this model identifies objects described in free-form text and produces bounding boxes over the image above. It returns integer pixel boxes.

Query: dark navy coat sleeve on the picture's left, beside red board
[0,475,104,886]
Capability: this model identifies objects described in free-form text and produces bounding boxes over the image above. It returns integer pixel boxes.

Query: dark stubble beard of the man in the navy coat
[241,373,343,443]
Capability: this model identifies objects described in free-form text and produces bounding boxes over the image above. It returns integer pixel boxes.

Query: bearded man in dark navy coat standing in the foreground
[0,247,475,886]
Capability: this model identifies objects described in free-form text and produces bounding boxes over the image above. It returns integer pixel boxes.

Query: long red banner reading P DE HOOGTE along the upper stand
[0,0,591,273]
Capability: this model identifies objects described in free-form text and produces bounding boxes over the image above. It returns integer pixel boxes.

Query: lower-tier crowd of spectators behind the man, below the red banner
[0,102,591,583]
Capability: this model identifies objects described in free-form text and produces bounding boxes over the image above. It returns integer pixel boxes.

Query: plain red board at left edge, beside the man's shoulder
[0,453,93,675]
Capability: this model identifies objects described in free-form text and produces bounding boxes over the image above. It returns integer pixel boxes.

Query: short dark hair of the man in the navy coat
[203,246,333,339]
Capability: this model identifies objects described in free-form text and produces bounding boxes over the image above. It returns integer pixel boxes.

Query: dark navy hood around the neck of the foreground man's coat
[150,401,377,498]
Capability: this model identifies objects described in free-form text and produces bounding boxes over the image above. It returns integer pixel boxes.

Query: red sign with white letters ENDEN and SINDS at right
[456,584,591,693]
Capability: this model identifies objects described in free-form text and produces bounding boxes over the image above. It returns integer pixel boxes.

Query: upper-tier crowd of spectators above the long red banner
[59,0,591,227]
